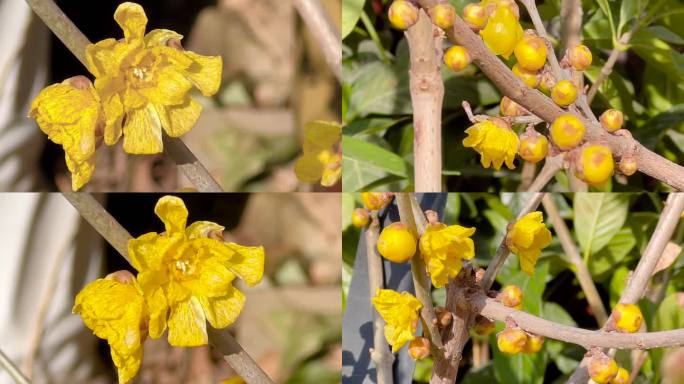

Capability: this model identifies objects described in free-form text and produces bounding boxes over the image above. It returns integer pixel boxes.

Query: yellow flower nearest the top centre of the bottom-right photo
[506,211,551,276]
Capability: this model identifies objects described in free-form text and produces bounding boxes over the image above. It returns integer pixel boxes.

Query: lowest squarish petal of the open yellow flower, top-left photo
[123,104,163,154]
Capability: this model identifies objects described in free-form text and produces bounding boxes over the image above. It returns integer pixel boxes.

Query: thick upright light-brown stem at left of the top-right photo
[406,10,444,192]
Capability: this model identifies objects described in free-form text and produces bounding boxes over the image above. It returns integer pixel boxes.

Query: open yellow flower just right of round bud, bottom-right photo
[420,223,475,288]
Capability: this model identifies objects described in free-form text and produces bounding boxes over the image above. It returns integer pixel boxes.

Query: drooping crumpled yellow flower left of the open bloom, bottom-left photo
[73,271,149,383]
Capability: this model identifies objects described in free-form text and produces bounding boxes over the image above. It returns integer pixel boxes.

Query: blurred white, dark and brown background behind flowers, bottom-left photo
[0,193,342,384]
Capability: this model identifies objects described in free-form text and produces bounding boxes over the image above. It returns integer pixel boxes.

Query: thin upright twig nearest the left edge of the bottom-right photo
[366,211,394,384]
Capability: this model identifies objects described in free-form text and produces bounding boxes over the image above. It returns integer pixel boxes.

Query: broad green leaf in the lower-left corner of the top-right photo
[342,135,408,192]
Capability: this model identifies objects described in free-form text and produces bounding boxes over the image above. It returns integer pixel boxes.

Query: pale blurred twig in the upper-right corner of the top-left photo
[294,0,342,83]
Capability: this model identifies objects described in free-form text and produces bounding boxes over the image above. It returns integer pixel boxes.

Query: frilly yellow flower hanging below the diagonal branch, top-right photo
[463,119,519,170]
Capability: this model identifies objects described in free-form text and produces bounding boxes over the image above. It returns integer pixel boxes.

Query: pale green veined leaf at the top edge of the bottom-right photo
[573,192,629,258]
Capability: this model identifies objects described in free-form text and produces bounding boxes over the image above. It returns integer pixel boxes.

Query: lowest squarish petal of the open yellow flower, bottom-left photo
[168,297,207,347]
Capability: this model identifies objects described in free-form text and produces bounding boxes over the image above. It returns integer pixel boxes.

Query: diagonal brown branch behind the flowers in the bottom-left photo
[62,192,273,384]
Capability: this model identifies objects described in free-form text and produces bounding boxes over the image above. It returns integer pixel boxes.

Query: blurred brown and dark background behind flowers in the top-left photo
[0,0,341,192]
